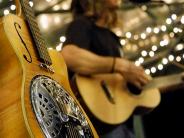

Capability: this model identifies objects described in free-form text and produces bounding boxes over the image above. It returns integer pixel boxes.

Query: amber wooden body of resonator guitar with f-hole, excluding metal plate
[0,15,98,138]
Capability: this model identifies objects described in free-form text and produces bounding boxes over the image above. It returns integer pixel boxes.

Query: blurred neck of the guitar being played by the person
[143,73,184,93]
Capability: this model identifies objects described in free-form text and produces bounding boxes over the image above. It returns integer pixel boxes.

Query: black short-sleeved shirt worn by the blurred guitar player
[64,16,121,78]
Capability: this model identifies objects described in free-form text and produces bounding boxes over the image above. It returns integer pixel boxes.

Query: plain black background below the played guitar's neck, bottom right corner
[143,85,184,138]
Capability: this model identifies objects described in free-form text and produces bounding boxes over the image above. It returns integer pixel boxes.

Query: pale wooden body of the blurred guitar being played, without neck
[75,74,160,125]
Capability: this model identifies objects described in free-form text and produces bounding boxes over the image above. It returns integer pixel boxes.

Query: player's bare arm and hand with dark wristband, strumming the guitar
[61,45,149,88]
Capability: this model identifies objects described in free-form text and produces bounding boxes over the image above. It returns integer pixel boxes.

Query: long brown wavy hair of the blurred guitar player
[71,0,117,27]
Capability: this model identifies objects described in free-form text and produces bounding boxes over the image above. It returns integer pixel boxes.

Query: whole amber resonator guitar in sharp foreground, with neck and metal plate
[0,0,98,138]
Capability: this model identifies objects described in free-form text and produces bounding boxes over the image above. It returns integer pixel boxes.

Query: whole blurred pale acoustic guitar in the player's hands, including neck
[75,73,183,125]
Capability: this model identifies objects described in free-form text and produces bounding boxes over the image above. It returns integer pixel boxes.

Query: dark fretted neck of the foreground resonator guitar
[20,0,52,65]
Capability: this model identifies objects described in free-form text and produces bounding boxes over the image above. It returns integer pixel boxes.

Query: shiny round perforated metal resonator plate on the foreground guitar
[31,76,94,138]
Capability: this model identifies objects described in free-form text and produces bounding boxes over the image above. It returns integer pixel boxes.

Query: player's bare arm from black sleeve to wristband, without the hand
[61,45,113,75]
